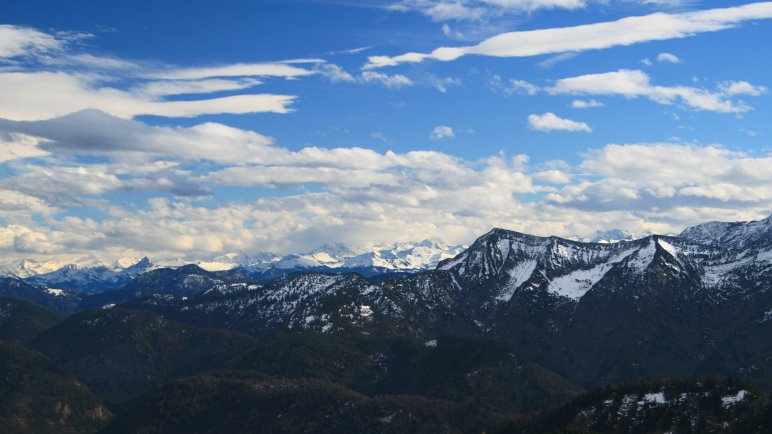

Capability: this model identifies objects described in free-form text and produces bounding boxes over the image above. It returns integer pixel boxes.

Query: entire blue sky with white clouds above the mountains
[0,0,772,261]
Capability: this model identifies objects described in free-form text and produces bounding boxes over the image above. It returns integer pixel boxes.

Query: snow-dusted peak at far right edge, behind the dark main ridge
[678,216,772,249]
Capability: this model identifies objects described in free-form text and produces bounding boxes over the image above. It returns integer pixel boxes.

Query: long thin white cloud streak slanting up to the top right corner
[364,2,772,69]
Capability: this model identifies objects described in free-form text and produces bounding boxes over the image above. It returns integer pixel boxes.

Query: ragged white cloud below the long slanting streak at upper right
[548,69,758,113]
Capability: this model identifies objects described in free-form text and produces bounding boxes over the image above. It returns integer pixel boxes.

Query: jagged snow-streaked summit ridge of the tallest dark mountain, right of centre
[438,229,714,304]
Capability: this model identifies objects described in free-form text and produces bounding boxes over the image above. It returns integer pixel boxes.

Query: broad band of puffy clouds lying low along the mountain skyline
[0,134,772,260]
